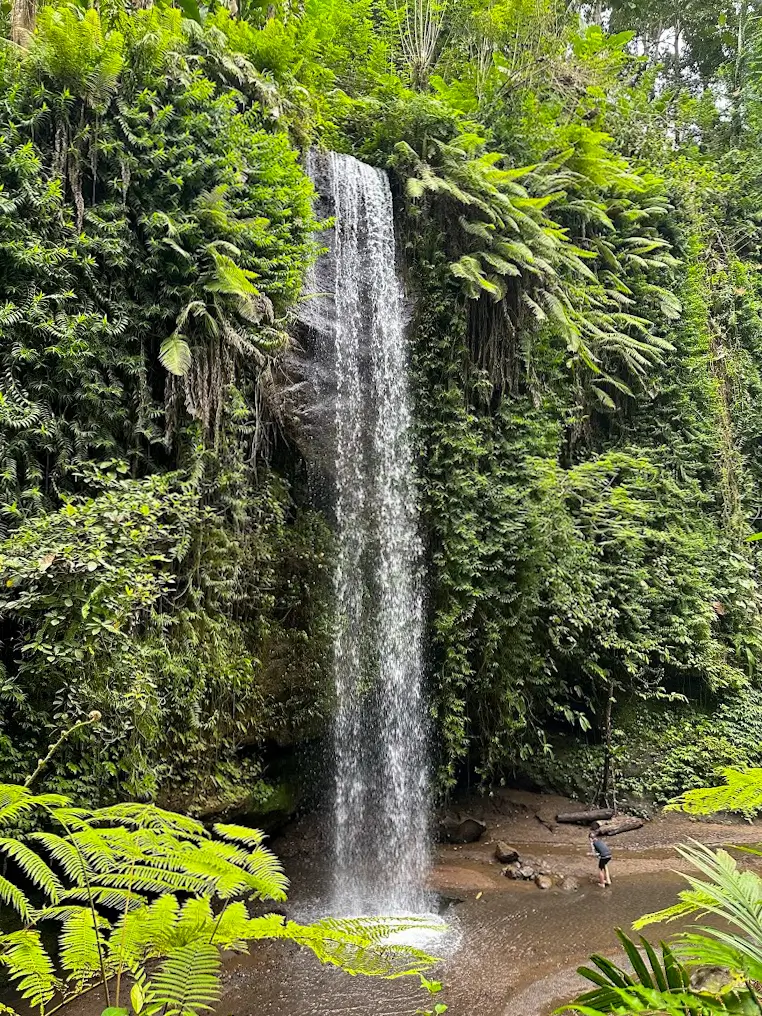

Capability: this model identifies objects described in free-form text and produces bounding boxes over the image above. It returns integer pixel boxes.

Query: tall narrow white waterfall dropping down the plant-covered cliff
[306,153,429,913]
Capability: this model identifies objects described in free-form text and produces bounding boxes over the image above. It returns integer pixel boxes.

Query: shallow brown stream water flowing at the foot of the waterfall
[220,861,685,1016]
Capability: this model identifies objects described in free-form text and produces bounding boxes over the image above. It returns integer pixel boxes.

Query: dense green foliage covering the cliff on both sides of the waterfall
[0,0,762,807]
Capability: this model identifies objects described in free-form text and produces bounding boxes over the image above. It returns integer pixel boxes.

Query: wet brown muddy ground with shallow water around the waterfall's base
[218,791,762,1016]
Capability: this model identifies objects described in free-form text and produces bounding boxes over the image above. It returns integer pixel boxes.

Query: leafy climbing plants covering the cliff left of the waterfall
[0,6,333,803]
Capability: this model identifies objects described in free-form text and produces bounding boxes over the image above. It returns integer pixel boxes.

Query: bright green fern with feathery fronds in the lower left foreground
[0,784,434,1016]
